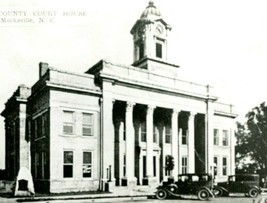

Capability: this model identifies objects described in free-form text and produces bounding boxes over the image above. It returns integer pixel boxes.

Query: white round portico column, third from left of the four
[172,109,179,180]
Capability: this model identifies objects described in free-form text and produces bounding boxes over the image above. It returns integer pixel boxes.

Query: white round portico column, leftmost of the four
[125,102,136,186]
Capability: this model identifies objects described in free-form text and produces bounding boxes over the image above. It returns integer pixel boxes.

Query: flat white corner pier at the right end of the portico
[205,101,214,174]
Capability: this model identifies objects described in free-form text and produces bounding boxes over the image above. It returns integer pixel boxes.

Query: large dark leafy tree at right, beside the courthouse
[236,103,267,174]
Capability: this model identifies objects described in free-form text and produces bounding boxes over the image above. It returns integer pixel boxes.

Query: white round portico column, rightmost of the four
[188,112,196,173]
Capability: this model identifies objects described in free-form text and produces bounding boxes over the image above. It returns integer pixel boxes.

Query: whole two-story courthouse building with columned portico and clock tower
[2,1,236,192]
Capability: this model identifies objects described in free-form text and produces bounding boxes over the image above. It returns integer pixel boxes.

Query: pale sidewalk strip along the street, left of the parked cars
[0,186,154,203]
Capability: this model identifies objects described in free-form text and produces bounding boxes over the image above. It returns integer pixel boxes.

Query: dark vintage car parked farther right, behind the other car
[213,174,261,198]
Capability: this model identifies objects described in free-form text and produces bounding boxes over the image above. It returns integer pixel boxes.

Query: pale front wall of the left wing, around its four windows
[50,90,100,192]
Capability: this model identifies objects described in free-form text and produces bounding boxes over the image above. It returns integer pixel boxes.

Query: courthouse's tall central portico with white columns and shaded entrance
[94,61,215,186]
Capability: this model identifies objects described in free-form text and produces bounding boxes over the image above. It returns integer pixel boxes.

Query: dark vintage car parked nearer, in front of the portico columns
[156,174,214,200]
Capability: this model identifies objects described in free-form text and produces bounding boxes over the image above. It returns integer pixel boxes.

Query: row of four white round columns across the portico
[125,102,196,184]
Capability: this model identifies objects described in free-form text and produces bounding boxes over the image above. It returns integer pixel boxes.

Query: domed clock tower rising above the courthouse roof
[131,1,171,69]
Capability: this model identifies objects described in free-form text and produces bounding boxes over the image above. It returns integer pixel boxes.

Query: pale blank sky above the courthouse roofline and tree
[0,0,267,168]
